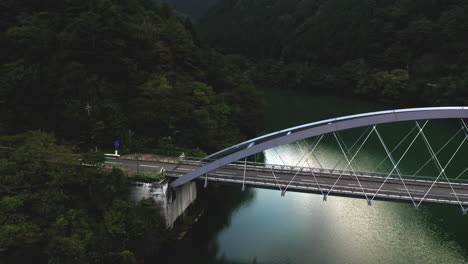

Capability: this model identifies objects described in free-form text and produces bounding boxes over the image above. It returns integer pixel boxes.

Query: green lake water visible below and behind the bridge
[162,89,468,264]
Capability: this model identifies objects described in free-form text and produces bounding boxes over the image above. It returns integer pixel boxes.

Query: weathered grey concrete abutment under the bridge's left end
[130,179,197,229]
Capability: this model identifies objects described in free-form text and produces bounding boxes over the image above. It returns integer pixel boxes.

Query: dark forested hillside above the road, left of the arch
[0,0,261,152]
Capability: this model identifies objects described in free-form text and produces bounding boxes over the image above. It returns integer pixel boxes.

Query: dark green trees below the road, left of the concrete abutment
[0,132,167,263]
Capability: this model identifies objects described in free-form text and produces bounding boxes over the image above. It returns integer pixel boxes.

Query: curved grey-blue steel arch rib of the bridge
[171,106,468,188]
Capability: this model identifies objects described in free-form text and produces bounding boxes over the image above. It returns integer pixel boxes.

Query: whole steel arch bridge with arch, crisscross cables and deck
[115,107,468,213]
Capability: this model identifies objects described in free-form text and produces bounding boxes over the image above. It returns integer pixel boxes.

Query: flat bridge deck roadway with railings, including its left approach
[106,159,468,206]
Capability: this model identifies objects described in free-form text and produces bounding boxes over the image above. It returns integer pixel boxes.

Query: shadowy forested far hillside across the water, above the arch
[199,0,468,105]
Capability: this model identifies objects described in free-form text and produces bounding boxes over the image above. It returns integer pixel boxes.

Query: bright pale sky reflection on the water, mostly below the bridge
[202,146,466,263]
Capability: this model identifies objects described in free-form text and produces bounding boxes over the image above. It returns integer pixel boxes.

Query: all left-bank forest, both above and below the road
[0,0,262,263]
